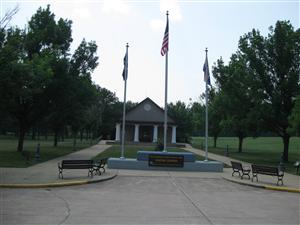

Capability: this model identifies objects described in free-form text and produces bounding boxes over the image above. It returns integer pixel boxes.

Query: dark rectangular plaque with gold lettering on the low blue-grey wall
[148,154,184,167]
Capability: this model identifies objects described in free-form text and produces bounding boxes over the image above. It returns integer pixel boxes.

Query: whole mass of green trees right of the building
[170,21,300,161]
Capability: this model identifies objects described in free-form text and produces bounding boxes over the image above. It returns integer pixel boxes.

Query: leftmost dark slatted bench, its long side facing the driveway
[58,160,94,179]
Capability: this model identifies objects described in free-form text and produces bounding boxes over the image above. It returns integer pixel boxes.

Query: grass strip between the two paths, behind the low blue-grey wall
[93,145,204,161]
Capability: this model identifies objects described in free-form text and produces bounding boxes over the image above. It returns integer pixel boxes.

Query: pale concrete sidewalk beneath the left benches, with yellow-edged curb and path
[0,141,117,188]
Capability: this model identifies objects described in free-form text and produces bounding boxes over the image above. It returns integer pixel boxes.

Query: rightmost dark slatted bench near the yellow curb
[251,164,284,185]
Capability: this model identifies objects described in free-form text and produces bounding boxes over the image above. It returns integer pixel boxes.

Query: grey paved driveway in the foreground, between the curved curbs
[0,170,300,225]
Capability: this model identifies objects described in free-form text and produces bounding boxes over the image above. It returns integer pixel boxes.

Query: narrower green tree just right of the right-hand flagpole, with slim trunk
[213,54,257,152]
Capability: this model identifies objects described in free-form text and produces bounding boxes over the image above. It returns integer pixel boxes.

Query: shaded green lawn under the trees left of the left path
[0,136,95,168]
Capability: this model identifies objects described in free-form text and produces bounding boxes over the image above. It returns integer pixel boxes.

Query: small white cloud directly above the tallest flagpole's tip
[160,0,182,21]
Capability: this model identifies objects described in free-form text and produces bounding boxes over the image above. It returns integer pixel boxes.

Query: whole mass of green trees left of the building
[0,5,121,151]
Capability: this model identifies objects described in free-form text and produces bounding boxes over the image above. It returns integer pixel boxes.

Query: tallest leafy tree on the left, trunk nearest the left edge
[0,5,86,151]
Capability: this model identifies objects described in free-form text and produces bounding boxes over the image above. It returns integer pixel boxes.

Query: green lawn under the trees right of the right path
[192,137,300,174]
